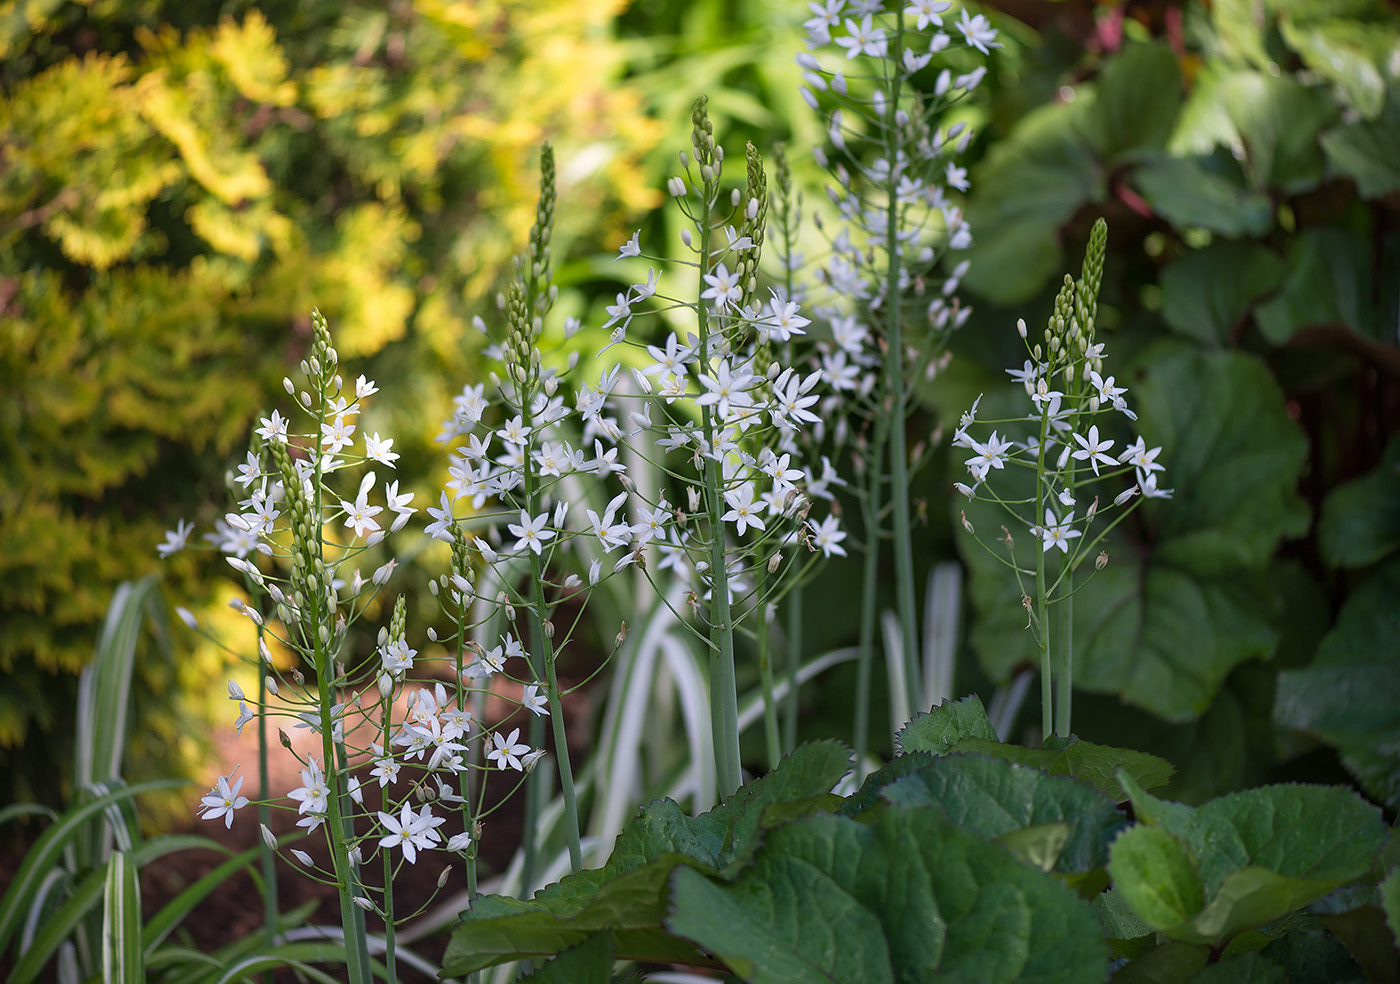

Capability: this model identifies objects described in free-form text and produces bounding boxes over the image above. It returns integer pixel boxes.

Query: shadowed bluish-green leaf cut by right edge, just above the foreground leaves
[1274,557,1400,809]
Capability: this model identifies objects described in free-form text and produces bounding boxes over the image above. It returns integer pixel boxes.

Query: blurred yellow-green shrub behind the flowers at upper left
[0,0,661,795]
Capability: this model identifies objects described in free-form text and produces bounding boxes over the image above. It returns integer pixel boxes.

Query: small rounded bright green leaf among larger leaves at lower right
[1109,826,1205,929]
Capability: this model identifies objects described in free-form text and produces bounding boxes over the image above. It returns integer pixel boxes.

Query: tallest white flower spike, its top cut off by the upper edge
[798,3,997,753]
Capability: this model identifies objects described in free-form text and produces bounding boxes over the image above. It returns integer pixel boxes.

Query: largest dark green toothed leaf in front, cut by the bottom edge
[668,808,1106,984]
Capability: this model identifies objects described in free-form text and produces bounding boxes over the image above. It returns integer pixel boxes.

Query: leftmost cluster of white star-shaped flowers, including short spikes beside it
[170,312,568,899]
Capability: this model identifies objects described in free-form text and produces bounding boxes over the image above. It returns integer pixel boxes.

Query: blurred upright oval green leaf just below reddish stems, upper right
[1088,43,1182,164]
